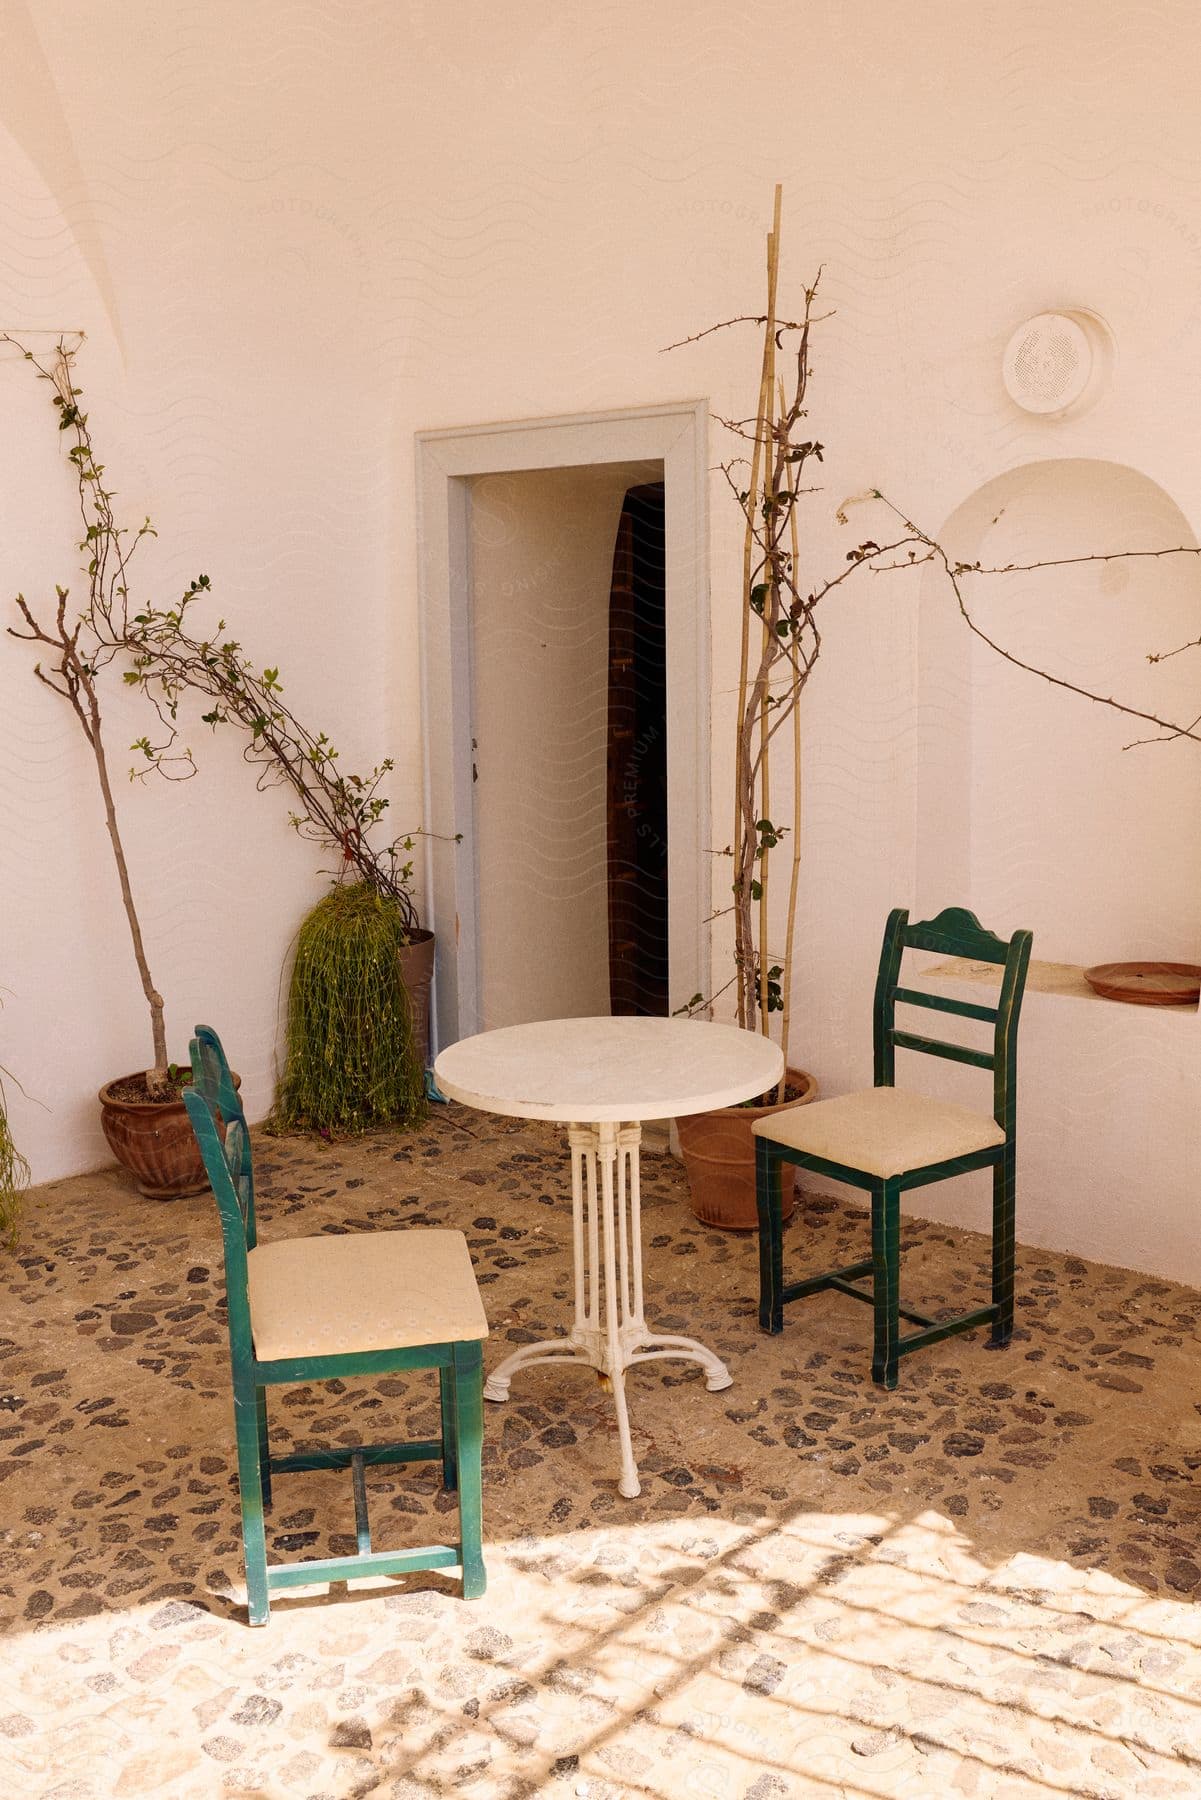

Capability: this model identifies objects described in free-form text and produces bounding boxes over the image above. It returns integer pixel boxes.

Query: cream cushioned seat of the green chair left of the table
[247,1229,488,1363]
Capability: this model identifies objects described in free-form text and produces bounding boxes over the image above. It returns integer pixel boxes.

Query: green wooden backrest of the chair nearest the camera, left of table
[184,1024,256,1354]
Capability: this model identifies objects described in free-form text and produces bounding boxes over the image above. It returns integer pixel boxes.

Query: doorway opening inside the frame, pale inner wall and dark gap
[468,461,666,1031]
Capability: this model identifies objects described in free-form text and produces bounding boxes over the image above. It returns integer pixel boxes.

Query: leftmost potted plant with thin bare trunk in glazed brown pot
[4,335,237,1199]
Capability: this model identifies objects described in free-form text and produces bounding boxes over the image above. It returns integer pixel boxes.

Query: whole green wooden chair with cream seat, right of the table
[754,907,1030,1388]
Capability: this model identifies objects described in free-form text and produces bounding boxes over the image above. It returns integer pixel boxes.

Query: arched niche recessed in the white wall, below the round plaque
[915,457,1201,967]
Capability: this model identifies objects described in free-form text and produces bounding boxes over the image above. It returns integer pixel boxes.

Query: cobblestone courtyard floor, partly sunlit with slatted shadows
[0,1107,1201,1800]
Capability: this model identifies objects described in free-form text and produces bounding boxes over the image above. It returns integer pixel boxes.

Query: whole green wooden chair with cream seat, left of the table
[184,1024,488,1625]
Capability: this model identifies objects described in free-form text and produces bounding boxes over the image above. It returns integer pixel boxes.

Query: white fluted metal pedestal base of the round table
[484,1121,733,1499]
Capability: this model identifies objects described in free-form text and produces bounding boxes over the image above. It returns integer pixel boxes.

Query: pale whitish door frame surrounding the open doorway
[416,400,709,1048]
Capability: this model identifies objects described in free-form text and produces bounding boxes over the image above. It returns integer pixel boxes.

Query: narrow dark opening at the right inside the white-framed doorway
[607,481,668,1017]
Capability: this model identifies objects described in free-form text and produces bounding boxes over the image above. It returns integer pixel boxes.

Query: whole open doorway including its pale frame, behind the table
[418,401,709,1044]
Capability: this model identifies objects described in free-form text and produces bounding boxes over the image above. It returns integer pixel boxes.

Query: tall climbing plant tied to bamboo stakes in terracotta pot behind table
[670,187,1201,1231]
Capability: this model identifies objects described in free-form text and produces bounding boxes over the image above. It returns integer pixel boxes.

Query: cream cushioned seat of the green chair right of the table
[754,1087,1005,1177]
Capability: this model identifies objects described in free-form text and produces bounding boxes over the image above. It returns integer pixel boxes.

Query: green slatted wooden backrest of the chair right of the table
[873,905,1032,1138]
